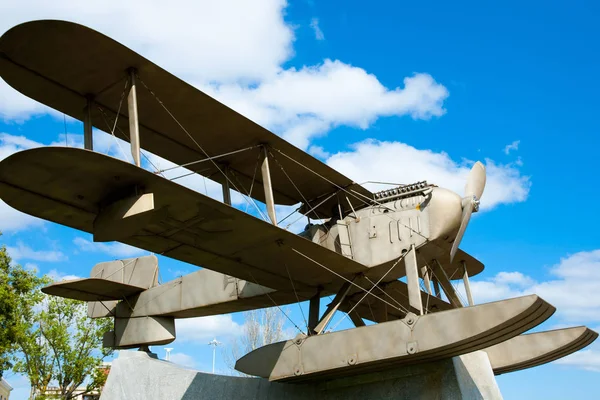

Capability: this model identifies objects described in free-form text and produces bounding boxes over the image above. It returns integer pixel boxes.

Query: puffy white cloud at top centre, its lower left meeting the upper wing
[206,65,448,149]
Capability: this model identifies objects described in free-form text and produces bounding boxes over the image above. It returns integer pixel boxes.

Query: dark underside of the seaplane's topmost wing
[0,20,373,218]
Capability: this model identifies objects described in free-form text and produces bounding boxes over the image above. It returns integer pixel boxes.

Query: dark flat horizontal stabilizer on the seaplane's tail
[42,278,146,301]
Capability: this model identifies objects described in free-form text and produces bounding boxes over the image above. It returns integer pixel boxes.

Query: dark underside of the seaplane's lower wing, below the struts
[0,147,367,298]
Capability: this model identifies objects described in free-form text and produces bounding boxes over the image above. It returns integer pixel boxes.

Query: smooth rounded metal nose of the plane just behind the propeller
[427,187,462,240]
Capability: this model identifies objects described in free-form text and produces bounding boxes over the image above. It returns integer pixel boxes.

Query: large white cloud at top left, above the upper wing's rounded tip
[0,0,294,85]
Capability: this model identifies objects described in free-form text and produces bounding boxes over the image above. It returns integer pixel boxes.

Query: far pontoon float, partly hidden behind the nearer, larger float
[484,326,598,375]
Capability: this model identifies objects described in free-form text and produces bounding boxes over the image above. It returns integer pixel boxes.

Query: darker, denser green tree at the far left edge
[0,233,49,377]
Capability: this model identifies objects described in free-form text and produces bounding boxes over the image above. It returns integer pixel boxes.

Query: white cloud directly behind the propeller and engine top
[327,139,531,210]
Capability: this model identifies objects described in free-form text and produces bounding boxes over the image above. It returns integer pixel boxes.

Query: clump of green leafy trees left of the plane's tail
[0,231,112,399]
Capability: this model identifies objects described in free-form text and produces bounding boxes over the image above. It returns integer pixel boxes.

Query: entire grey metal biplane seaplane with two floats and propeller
[0,20,597,382]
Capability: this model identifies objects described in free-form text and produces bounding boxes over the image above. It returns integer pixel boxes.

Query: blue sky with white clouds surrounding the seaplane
[0,0,600,399]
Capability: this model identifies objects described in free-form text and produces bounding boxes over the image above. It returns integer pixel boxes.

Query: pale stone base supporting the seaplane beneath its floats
[100,350,502,400]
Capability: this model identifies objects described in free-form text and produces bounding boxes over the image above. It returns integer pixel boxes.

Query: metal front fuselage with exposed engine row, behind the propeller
[300,183,462,276]
